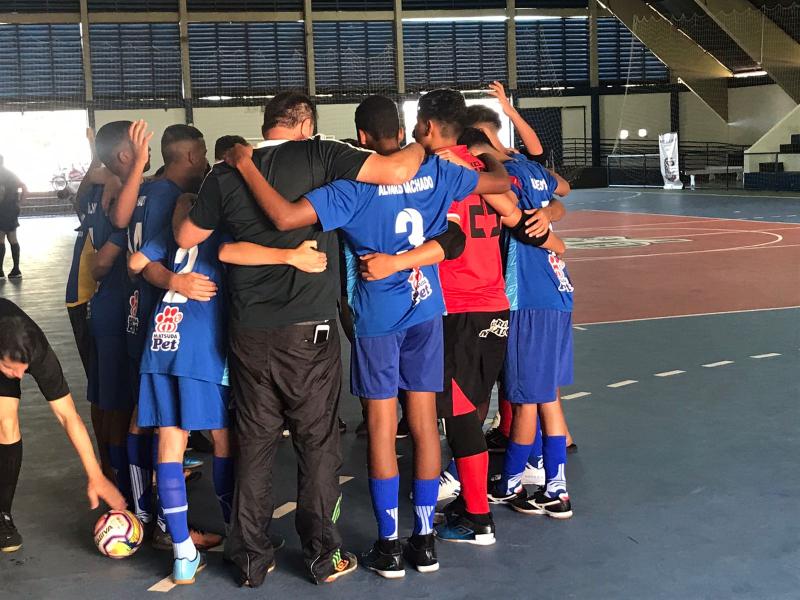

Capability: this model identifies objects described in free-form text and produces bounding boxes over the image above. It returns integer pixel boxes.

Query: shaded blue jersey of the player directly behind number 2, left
[126,179,182,360]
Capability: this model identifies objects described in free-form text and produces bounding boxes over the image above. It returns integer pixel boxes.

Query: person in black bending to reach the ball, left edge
[0,298,125,552]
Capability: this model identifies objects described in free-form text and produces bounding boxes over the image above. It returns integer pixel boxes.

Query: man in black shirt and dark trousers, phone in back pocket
[175,92,425,587]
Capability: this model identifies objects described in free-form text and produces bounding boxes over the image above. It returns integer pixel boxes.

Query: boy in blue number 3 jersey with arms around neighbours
[219,96,508,578]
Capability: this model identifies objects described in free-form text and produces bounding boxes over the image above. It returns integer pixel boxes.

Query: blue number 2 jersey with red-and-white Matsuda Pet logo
[139,227,228,385]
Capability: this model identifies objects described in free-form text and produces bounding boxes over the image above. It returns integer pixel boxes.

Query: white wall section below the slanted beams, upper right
[680,85,796,145]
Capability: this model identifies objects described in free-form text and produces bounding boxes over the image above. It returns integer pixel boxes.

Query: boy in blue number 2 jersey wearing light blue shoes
[128,194,228,584]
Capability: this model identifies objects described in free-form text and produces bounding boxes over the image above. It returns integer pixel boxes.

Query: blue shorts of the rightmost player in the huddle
[503,309,572,404]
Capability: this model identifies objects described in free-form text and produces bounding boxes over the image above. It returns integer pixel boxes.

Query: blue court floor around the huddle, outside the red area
[0,195,800,600]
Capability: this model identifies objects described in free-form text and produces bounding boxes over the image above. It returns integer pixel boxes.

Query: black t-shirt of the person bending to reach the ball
[0,298,69,402]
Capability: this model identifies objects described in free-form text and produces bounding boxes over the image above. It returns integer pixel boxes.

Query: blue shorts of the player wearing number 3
[350,317,444,400]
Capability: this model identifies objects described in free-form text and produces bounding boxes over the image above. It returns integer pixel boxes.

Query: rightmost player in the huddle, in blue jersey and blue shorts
[466,130,573,519]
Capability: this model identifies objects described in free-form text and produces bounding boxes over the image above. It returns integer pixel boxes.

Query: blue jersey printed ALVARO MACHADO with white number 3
[306,156,478,337]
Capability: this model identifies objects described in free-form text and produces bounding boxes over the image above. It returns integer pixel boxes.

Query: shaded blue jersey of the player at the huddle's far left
[81,185,128,336]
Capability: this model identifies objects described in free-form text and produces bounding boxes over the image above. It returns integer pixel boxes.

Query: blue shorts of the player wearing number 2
[137,373,228,431]
